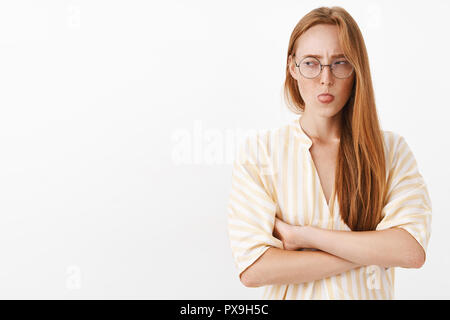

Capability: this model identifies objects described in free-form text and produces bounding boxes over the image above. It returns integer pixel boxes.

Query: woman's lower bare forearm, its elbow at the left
[241,248,361,287]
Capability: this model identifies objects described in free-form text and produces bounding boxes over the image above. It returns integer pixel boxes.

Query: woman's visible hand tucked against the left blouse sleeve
[273,217,309,250]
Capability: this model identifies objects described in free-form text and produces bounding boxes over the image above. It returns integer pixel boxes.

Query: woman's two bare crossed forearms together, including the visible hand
[241,218,425,287]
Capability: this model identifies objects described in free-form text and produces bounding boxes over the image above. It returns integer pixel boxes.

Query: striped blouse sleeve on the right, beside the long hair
[376,135,431,253]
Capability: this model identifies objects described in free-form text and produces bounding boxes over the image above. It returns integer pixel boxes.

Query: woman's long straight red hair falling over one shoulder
[284,7,386,231]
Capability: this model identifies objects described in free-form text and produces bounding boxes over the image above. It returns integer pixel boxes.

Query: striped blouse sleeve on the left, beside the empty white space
[227,132,283,277]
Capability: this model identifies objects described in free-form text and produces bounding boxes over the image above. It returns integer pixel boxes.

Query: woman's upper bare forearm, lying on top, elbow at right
[298,226,425,268]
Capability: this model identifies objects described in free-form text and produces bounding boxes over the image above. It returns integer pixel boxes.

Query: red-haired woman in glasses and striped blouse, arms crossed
[228,7,431,299]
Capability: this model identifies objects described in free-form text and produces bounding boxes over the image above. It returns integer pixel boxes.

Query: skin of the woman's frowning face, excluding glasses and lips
[289,24,355,117]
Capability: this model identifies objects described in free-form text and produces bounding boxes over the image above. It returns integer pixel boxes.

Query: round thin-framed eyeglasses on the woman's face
[294,55,353,79]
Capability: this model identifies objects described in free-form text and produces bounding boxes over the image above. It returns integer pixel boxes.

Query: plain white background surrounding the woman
[0,0,450,299]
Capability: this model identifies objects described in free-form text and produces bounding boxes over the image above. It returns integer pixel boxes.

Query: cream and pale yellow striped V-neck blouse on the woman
[227,118,431,300]
